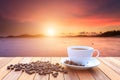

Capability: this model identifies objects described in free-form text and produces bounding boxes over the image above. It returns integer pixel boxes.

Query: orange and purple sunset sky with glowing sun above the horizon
[0,0,120,35]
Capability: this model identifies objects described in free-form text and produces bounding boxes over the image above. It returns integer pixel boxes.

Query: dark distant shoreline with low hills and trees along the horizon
[0,30,120,38]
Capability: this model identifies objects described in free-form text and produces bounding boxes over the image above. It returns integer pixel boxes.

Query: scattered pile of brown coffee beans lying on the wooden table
[7,61,68,77]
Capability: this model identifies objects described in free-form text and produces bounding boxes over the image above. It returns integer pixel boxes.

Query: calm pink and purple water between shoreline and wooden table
[0,37,120,57]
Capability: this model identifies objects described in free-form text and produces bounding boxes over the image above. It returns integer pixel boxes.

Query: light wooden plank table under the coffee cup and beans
[0,57,120,80]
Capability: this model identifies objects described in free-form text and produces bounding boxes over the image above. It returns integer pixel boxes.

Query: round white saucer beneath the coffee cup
[61,58,100,70]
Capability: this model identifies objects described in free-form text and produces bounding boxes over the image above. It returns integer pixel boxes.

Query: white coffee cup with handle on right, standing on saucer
[67,46,100,65]
